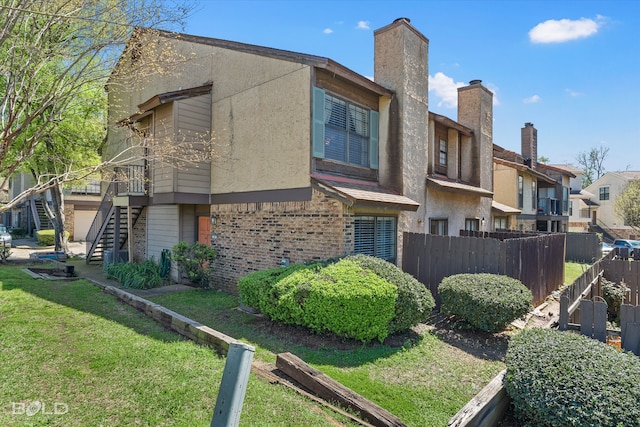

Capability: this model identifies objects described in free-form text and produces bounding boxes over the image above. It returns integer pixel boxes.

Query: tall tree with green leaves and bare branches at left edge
[0,0,199,249]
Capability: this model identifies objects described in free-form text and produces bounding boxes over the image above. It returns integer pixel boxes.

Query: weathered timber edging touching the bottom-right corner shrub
[447,369,510,427]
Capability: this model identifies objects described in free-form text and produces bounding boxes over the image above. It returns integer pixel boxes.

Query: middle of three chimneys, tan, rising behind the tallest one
[458,80,493,191]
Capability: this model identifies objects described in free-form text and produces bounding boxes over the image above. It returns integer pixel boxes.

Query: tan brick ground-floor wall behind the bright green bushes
[211,190,353,293]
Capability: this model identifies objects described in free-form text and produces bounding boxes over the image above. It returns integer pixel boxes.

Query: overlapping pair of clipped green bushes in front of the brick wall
[238,255,435,342]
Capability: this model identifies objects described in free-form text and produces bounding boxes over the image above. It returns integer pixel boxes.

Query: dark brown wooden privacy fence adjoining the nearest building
[402,233,565,308]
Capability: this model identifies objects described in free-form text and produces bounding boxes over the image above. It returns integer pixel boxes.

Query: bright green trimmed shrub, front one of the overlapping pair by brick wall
[238,260,398,342]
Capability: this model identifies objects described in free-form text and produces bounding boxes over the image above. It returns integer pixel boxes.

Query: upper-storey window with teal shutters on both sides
[313,88,378,169]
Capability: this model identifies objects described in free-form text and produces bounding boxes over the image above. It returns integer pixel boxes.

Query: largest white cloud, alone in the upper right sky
[529,15,604,43]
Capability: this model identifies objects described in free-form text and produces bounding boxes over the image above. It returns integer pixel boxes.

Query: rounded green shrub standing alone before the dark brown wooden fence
[438,273,533,332]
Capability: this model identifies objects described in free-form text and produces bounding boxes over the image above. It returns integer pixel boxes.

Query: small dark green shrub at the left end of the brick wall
[172,242,218,289]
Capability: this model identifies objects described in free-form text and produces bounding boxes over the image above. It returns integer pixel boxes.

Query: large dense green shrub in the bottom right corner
[504,329,640,427]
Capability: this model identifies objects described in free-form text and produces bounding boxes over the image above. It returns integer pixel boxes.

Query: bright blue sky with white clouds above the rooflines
[184,0,640,171]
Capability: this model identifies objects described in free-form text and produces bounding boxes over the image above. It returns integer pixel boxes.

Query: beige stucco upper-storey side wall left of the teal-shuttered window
[107,36,311,194]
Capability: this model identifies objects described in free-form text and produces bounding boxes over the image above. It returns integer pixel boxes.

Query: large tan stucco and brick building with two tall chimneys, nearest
[97,18,493,292]
